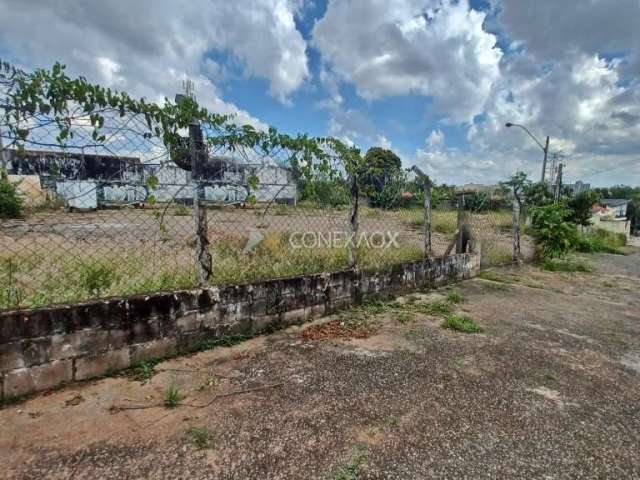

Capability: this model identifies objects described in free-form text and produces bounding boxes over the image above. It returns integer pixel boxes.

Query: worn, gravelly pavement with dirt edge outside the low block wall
[0,250,640,479]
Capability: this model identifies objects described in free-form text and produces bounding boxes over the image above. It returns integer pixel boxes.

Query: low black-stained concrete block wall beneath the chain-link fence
[0,254,480,399]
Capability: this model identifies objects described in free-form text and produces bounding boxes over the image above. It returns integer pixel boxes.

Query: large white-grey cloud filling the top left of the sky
[0,0,309,124]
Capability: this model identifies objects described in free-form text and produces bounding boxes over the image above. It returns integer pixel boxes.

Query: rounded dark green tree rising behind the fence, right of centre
[358,147,403,208]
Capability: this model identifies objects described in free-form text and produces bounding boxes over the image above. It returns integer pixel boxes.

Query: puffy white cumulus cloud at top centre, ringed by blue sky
[313,0,502,122]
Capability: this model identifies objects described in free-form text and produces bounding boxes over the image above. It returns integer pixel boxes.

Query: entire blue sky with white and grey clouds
[0,0,640,185]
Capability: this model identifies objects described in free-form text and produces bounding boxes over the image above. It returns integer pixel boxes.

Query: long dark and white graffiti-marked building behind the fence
[7,150,297,209]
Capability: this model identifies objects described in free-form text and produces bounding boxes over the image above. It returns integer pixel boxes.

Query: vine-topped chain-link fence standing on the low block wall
[0,66,528,309]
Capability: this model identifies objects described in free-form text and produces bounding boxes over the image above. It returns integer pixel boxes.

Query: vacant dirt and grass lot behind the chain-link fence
[0,205,532,309]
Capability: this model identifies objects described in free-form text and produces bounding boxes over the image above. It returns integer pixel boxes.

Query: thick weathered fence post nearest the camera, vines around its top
[189,121,213,287]
